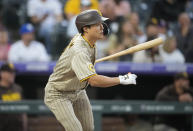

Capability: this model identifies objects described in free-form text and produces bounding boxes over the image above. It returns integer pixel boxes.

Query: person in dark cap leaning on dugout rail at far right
[156,72,193,131]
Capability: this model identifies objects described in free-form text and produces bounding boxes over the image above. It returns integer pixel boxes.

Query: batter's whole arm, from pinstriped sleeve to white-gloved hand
[71,52,137,87]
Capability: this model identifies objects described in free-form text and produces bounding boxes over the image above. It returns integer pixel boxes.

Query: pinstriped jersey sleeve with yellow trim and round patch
[71,52,97,82]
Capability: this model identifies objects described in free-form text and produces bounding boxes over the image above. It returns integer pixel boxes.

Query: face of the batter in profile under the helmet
[89,23,104,39]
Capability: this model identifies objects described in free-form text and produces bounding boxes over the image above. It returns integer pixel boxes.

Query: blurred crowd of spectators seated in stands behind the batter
[0,0,193,63]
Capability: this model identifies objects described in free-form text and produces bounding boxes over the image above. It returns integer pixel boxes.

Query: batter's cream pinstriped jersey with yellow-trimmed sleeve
[48,34,96,91]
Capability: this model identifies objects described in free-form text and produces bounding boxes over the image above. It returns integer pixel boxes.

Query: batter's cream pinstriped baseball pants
[44,85,94,131]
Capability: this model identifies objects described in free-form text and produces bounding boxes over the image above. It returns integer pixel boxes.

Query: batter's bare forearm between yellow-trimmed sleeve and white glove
[88,75,120,87]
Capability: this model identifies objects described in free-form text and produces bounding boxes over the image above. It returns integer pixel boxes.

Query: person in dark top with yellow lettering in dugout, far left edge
[0,63,27,131]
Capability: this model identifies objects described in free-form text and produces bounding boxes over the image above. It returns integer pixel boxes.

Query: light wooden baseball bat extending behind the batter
[95,37,163,63]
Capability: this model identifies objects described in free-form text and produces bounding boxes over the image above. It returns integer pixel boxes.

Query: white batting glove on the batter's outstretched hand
[119,73,137,85]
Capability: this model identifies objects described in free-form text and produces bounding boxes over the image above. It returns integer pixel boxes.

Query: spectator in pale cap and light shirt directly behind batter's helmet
[67,0,92,38]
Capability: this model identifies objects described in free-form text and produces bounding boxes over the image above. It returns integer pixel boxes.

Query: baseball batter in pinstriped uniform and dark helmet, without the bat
[44,10,137,131]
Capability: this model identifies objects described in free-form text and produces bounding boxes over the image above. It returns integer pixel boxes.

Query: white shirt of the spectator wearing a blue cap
[8,40,49,62]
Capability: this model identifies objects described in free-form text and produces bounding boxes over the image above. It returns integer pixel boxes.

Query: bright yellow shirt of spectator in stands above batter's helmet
[64,0,99,20]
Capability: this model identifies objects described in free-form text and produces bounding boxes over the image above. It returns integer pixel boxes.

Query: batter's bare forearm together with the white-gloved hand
[87,73,137,87]
